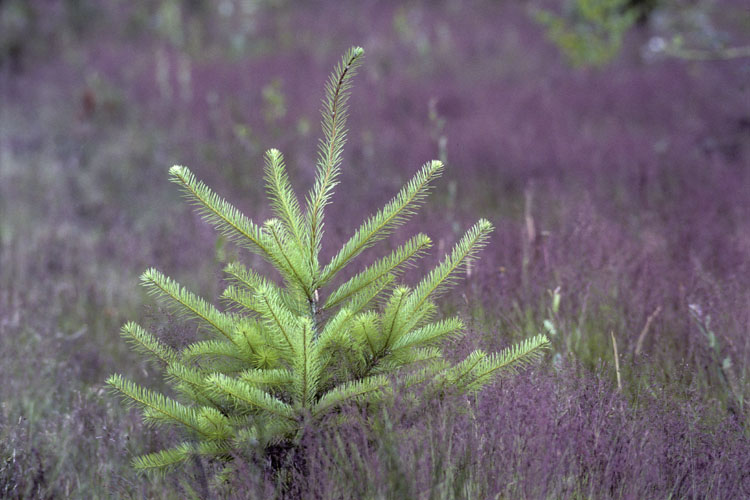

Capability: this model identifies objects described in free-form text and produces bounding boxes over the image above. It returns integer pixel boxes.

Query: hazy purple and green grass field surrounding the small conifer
[0,0,750,500]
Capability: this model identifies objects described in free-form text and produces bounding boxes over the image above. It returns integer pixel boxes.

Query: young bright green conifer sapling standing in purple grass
[107,47,548,471]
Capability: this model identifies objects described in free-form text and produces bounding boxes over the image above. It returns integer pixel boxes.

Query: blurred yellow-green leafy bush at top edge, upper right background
[533,0,638,66]
